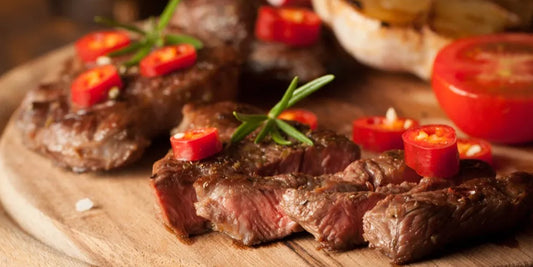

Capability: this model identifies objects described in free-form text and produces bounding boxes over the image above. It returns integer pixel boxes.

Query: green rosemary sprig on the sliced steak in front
[231,74,335,145]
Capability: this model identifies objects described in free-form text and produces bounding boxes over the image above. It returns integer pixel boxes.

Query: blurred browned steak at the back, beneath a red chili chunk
[171,0,331,84]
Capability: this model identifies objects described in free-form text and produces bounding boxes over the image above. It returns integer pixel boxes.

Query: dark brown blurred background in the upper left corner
[0,0,167,74]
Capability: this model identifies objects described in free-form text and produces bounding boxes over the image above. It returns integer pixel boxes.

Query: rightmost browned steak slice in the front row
[363,173,533,264]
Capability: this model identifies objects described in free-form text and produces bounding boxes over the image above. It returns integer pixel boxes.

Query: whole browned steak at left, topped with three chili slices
[17,47,239,172]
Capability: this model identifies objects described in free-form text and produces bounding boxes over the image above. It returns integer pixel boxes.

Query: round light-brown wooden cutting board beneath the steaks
[0,47,533,266]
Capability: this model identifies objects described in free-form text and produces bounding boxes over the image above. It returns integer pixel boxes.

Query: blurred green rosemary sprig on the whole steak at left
[94,0,203,68]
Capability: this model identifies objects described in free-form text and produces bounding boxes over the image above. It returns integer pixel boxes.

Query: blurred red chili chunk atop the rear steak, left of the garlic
[255,6,322,46]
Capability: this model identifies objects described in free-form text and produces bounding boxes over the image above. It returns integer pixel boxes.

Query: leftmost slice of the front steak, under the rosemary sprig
[151,102,360,241]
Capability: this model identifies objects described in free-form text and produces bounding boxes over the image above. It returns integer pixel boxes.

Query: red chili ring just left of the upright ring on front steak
[352,116,418,152]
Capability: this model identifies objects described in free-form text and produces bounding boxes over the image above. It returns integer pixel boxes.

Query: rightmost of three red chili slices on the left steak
[139,44,197,77]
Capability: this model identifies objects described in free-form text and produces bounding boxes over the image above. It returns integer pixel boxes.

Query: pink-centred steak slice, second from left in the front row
[194,175,306,246]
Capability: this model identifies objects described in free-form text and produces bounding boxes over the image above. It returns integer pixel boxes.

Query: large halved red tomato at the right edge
[432,33,533,146]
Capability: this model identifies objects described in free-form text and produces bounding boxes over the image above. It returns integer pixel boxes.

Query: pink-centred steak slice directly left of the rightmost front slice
[280,157,495,250]
